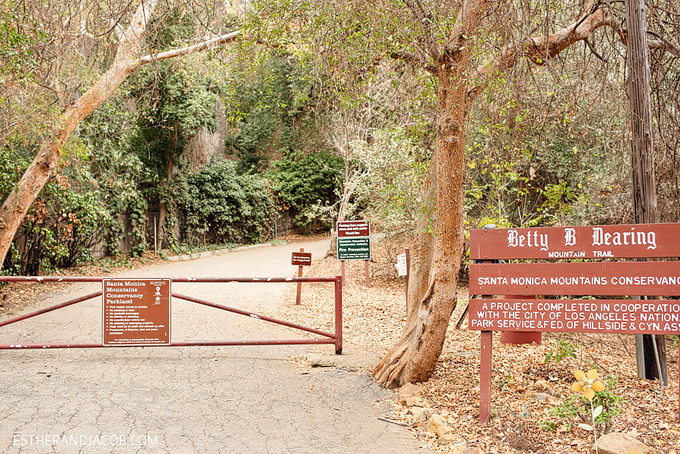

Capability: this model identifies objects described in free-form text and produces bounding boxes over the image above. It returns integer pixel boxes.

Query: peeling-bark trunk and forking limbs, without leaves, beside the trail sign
[373,1,624,387]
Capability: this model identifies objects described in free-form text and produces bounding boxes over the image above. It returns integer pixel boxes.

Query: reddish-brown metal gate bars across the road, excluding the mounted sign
[0,276,342,355]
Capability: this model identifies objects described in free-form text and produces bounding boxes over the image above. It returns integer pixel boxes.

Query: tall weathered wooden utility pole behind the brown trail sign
[626,0,668,384]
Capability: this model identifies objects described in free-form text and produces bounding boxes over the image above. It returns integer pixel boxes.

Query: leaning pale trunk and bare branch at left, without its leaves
[0,0,240,263]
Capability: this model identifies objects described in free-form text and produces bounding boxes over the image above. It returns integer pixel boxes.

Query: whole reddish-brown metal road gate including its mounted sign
[0,276,342,355]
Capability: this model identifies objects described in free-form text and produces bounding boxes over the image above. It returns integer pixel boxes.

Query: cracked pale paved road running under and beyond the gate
[0,241,429,454]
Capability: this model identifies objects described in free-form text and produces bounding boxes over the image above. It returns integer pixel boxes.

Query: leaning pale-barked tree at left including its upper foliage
[0,0,244,270]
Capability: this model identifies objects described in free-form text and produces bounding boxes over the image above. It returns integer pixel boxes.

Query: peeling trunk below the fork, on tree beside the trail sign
[373,62,467,387]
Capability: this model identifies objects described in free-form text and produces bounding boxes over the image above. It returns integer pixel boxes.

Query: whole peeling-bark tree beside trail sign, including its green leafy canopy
[246,0,648,387]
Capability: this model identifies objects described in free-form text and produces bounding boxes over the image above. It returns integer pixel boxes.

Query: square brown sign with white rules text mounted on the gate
[102,278,171,345]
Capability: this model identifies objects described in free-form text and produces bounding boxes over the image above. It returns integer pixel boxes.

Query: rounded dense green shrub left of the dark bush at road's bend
[184,161,274,245]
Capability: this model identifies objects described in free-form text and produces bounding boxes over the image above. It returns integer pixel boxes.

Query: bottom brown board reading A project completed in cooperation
[468,299,680,335]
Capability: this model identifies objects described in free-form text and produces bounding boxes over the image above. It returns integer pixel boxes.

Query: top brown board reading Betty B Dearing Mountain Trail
[470,224,680,260]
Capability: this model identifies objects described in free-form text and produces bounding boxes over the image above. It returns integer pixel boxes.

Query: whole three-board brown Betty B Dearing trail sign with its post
[468,224,680,422]
